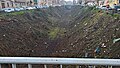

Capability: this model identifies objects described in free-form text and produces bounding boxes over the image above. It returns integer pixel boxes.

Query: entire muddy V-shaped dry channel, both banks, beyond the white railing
[0,6,120,68]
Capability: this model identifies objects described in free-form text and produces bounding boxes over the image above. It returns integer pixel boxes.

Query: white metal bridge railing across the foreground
[0,57,120,68]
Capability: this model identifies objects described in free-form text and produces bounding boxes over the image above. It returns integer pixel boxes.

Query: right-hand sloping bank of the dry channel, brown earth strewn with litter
[53,7,120,58]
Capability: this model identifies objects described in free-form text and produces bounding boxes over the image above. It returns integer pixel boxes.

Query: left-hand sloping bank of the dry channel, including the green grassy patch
[0,7,73,56]
